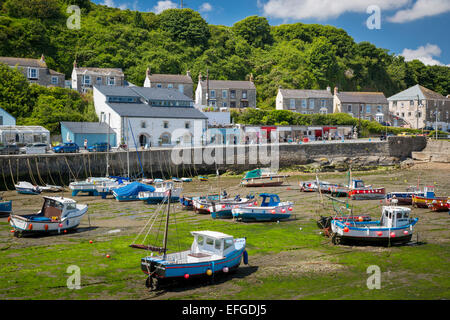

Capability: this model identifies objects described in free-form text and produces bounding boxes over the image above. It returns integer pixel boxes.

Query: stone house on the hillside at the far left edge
[0,55,65,88]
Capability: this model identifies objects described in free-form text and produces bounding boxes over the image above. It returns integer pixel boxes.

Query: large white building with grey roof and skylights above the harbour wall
[94,86,208,148]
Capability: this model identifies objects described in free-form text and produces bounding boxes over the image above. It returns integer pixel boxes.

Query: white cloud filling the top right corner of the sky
[387,0,450,23]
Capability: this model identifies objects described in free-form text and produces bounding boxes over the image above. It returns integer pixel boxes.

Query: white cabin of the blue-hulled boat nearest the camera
[189,231,234,258]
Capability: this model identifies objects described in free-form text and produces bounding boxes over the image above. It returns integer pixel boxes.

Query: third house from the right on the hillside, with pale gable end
[276,87,333,114]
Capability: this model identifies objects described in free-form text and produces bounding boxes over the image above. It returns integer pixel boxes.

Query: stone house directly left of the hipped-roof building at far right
[333,87,389,123]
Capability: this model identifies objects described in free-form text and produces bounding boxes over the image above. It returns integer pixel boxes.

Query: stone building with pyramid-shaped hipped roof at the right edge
[388,84,450,131]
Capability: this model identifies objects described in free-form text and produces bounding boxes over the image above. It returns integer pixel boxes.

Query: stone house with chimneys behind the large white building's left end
[72,61,125,93]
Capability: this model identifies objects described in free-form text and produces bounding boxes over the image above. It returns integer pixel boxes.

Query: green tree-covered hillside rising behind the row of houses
[0,0,450,131]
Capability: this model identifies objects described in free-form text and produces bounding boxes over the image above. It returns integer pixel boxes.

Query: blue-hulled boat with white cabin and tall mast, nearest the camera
[130,190,248,290]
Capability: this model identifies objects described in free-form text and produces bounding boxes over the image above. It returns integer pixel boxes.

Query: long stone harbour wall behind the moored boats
[0,137,427,190]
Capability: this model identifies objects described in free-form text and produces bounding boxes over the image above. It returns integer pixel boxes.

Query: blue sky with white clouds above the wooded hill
[94,0,450,66]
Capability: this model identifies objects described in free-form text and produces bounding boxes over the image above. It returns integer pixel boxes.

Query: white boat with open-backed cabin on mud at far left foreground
[8,197,88,237]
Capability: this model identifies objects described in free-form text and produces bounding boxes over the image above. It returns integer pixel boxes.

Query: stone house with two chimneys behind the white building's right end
[144,68,194,99]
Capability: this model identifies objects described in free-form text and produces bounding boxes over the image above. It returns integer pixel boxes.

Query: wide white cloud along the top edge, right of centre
[262,0,410,19]
